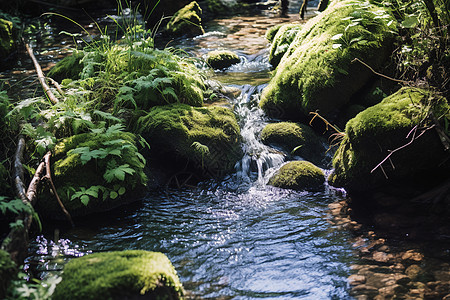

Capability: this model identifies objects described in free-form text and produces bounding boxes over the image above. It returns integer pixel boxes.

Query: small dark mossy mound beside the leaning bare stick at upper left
[48,51,84,82]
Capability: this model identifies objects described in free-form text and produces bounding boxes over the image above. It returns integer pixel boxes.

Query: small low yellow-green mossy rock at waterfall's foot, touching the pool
[268,161,325,191]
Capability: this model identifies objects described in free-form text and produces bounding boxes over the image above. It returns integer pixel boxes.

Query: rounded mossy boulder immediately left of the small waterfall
[137,104,242,177]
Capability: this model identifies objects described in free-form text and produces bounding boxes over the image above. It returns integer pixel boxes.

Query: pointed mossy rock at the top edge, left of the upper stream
[166,1,205,36]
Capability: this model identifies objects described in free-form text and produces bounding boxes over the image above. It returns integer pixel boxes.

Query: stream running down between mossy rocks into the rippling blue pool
[8,1,450,299]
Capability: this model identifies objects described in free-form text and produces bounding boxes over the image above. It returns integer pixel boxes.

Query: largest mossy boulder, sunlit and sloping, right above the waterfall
[260,0,395,120]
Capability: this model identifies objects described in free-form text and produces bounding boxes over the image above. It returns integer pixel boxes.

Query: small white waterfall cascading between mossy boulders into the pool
[234,85,284,185]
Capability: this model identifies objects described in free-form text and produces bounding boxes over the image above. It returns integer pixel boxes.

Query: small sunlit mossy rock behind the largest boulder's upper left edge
[268,24,302,67]
